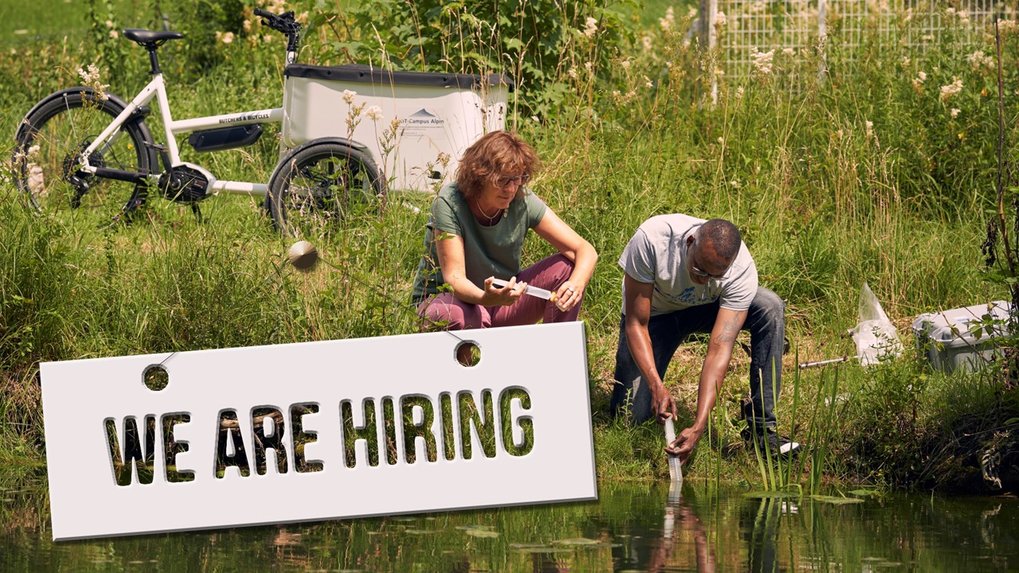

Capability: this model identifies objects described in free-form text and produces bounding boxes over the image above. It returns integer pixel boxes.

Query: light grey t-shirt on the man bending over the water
[620,214,757,316]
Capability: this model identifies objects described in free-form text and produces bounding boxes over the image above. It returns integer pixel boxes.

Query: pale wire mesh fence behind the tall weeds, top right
[713,0,1016,76]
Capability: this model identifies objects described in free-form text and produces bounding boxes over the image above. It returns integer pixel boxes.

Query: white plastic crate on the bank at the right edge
[913,301,1011,372]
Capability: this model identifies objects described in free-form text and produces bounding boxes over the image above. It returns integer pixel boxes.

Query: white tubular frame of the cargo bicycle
[81,73,283,197]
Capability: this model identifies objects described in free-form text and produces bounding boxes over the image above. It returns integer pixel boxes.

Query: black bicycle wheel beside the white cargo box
[268,143,383,238]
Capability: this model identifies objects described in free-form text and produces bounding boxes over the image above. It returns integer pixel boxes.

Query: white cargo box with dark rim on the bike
[282,64,514,191]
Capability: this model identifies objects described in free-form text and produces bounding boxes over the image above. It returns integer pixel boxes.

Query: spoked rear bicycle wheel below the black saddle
[14,89,150,222]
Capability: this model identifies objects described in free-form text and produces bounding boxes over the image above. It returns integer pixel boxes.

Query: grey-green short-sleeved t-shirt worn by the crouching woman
[413,184,548,304]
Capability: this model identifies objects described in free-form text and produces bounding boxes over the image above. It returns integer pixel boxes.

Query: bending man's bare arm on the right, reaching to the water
[665,308,747,462]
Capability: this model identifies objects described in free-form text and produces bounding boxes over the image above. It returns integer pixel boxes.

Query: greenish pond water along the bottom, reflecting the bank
[0,480,1019,572]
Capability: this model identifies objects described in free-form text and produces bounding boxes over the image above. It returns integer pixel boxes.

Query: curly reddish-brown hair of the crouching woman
[457,132,541,199]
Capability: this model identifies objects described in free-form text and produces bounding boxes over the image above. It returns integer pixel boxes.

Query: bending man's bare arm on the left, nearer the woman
[620,274,676,421]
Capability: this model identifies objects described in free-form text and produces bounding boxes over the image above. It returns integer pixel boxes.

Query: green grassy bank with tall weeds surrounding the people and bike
[0,0,1019,488]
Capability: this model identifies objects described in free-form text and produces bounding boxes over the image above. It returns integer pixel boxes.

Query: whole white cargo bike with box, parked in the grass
[13,10,513,236]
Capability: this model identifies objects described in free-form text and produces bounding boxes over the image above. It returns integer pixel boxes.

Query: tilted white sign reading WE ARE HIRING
[41,322,597,539]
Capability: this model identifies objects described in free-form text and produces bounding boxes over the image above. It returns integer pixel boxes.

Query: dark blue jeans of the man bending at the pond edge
[610,288,786,429]
